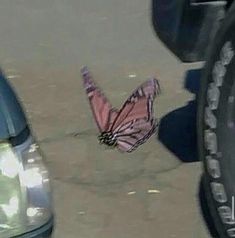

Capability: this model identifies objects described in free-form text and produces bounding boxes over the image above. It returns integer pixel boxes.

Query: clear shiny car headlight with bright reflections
[0,138,52,238]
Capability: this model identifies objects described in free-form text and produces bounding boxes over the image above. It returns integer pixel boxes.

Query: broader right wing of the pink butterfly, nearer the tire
[111,79,160,152]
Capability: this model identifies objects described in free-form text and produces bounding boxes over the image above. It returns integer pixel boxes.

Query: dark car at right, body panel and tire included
[152,0,235,238]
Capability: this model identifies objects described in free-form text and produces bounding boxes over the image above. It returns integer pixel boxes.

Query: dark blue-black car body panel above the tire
[152,0,228,62]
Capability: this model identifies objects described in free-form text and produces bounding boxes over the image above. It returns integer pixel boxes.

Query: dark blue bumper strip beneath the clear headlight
[12,218,54,238]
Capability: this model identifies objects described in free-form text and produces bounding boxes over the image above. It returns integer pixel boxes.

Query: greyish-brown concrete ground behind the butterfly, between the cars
[0,0,209,238]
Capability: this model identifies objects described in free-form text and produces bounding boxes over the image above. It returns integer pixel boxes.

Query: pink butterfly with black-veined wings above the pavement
[81,67,160,152]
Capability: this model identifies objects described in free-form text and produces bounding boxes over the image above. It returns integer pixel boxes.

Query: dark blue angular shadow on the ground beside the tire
[158,69,201,162]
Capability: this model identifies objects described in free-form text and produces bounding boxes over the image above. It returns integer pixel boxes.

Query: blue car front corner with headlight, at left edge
[0,71,54,238]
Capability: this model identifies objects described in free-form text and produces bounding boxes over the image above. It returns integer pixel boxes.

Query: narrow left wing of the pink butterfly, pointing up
[81,67,118,132]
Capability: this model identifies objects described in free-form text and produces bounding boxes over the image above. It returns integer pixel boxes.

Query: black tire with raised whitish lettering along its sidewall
[198,4,235,238]
